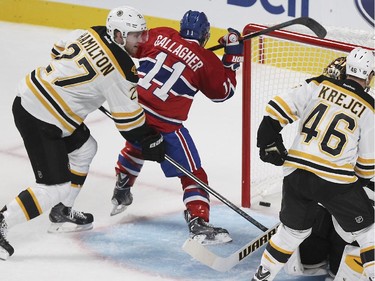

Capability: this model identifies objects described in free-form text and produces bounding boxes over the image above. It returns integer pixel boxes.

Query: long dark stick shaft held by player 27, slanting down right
[99,106,268,231]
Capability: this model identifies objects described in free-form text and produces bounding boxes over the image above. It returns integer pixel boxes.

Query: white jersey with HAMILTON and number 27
[18,26,145,137]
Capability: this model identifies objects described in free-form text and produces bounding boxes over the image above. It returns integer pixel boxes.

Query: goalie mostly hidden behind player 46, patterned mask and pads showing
[284,57,375,281]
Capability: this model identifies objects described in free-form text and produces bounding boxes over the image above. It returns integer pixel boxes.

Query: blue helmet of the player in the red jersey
[180,10,210,47]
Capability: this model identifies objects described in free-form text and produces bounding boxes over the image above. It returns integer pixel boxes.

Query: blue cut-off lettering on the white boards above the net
[227,0,309,17]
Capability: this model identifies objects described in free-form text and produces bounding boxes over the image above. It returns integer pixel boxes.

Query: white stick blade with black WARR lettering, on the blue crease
[182,223,280,272]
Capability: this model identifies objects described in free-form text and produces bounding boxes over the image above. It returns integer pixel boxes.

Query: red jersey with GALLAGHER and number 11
[136,27,237,132]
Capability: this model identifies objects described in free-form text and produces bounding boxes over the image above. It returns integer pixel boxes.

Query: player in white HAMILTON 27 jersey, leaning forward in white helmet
[0,6,164,260]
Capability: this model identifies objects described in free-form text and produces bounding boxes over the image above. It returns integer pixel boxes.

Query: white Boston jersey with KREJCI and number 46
[266,76,375,183]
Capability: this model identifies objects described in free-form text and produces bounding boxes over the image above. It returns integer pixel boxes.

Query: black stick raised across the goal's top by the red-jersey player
[208,17,327,51]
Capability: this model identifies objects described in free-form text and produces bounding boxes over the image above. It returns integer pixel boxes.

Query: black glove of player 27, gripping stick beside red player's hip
[141,133,165,163]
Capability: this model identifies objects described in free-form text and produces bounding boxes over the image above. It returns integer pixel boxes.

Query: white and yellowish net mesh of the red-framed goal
[243,24,373,207]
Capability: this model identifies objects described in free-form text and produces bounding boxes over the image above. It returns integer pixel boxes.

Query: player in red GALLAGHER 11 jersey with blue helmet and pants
[111,11,243,243]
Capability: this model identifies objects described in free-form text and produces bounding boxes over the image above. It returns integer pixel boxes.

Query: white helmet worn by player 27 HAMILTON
[106,6,147,48]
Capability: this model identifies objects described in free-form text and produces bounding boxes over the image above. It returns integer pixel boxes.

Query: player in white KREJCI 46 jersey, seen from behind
[252,48,375,281]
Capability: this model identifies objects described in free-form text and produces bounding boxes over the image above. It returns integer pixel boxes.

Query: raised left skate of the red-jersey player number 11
[111,173,133,216]
